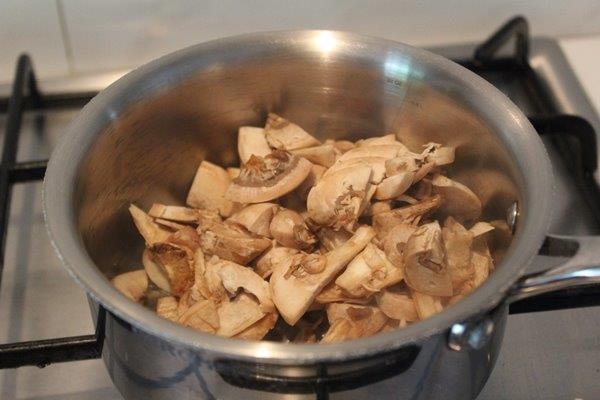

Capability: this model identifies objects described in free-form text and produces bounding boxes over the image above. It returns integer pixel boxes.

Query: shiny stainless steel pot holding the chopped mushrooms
[44,31,600,400]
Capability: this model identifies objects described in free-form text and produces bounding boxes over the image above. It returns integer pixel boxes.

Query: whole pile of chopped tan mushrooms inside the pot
[113,114,499,343]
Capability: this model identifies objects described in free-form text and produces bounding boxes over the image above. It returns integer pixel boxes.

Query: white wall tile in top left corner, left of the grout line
[0,0,69,82]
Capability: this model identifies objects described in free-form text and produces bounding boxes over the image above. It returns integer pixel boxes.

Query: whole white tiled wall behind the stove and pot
[0,0,600,82]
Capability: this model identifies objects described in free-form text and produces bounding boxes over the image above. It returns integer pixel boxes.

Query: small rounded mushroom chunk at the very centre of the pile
[270,209,317,250]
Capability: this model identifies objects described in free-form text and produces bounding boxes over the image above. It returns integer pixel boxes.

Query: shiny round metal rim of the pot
[43,30,552,365]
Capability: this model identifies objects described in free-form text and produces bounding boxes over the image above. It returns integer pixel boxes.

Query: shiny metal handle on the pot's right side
[507,235,600,311]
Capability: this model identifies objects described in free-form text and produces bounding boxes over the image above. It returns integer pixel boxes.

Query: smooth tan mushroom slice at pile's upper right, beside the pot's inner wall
[431,174,481,221]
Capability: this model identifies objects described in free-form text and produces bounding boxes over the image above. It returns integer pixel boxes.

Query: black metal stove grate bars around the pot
[0,17,600,376]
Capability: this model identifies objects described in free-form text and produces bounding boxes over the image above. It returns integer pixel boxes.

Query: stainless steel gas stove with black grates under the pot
[0,17,600,400]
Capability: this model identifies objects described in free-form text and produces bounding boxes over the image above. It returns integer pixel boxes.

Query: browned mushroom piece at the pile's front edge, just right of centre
[321,303,388,343]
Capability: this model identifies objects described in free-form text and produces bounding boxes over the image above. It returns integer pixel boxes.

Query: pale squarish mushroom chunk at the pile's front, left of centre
[217,293,265,337]
